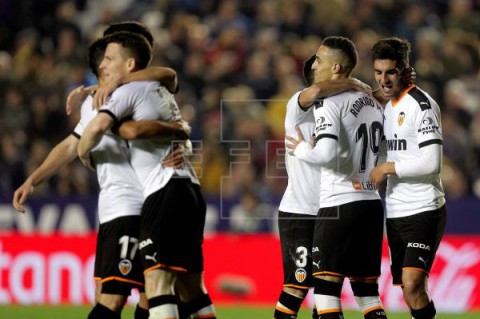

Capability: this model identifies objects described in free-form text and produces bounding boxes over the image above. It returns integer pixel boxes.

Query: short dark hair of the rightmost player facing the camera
[371,37,411,71]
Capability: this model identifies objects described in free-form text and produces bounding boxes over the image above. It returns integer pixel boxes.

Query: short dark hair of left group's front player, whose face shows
[104,31,152,70]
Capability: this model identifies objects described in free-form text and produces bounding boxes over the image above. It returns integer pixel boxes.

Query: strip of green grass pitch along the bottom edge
[0,305,480,319]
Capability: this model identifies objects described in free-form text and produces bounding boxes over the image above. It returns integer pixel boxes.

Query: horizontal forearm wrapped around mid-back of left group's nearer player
[115,120,192,140]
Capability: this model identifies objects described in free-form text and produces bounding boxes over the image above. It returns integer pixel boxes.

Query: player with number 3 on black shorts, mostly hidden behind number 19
[274,55,371,319]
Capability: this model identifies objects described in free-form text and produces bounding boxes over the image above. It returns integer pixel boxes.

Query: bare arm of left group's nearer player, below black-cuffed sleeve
[77,112,114,168]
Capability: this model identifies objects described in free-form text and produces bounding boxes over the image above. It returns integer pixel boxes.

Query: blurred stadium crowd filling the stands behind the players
[0,0,480,231]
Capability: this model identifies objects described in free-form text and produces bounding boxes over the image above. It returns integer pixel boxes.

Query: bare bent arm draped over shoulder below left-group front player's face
[93,66,178,109]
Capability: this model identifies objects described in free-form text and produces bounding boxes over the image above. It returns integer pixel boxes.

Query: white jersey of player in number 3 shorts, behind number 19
[279,91,320,216]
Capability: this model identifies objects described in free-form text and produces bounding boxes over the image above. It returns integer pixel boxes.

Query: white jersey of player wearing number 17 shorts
[73,96,144,224]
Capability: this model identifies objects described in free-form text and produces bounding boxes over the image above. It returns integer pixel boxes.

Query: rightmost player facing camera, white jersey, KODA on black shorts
[371,38,447,319]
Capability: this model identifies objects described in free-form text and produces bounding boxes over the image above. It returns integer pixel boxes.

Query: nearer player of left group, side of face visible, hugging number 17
[78,32,216,319]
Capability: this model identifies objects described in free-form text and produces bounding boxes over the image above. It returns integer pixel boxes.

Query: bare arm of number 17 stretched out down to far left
[12,135,78,213]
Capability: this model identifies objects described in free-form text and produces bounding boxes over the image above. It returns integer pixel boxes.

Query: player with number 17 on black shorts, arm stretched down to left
[13,33,185,319]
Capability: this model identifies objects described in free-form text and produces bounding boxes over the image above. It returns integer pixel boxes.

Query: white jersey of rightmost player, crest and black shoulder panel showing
[385,85,445,218]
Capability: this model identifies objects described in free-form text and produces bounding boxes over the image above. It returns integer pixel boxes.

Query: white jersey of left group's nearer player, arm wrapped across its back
[100,81,199,198]
